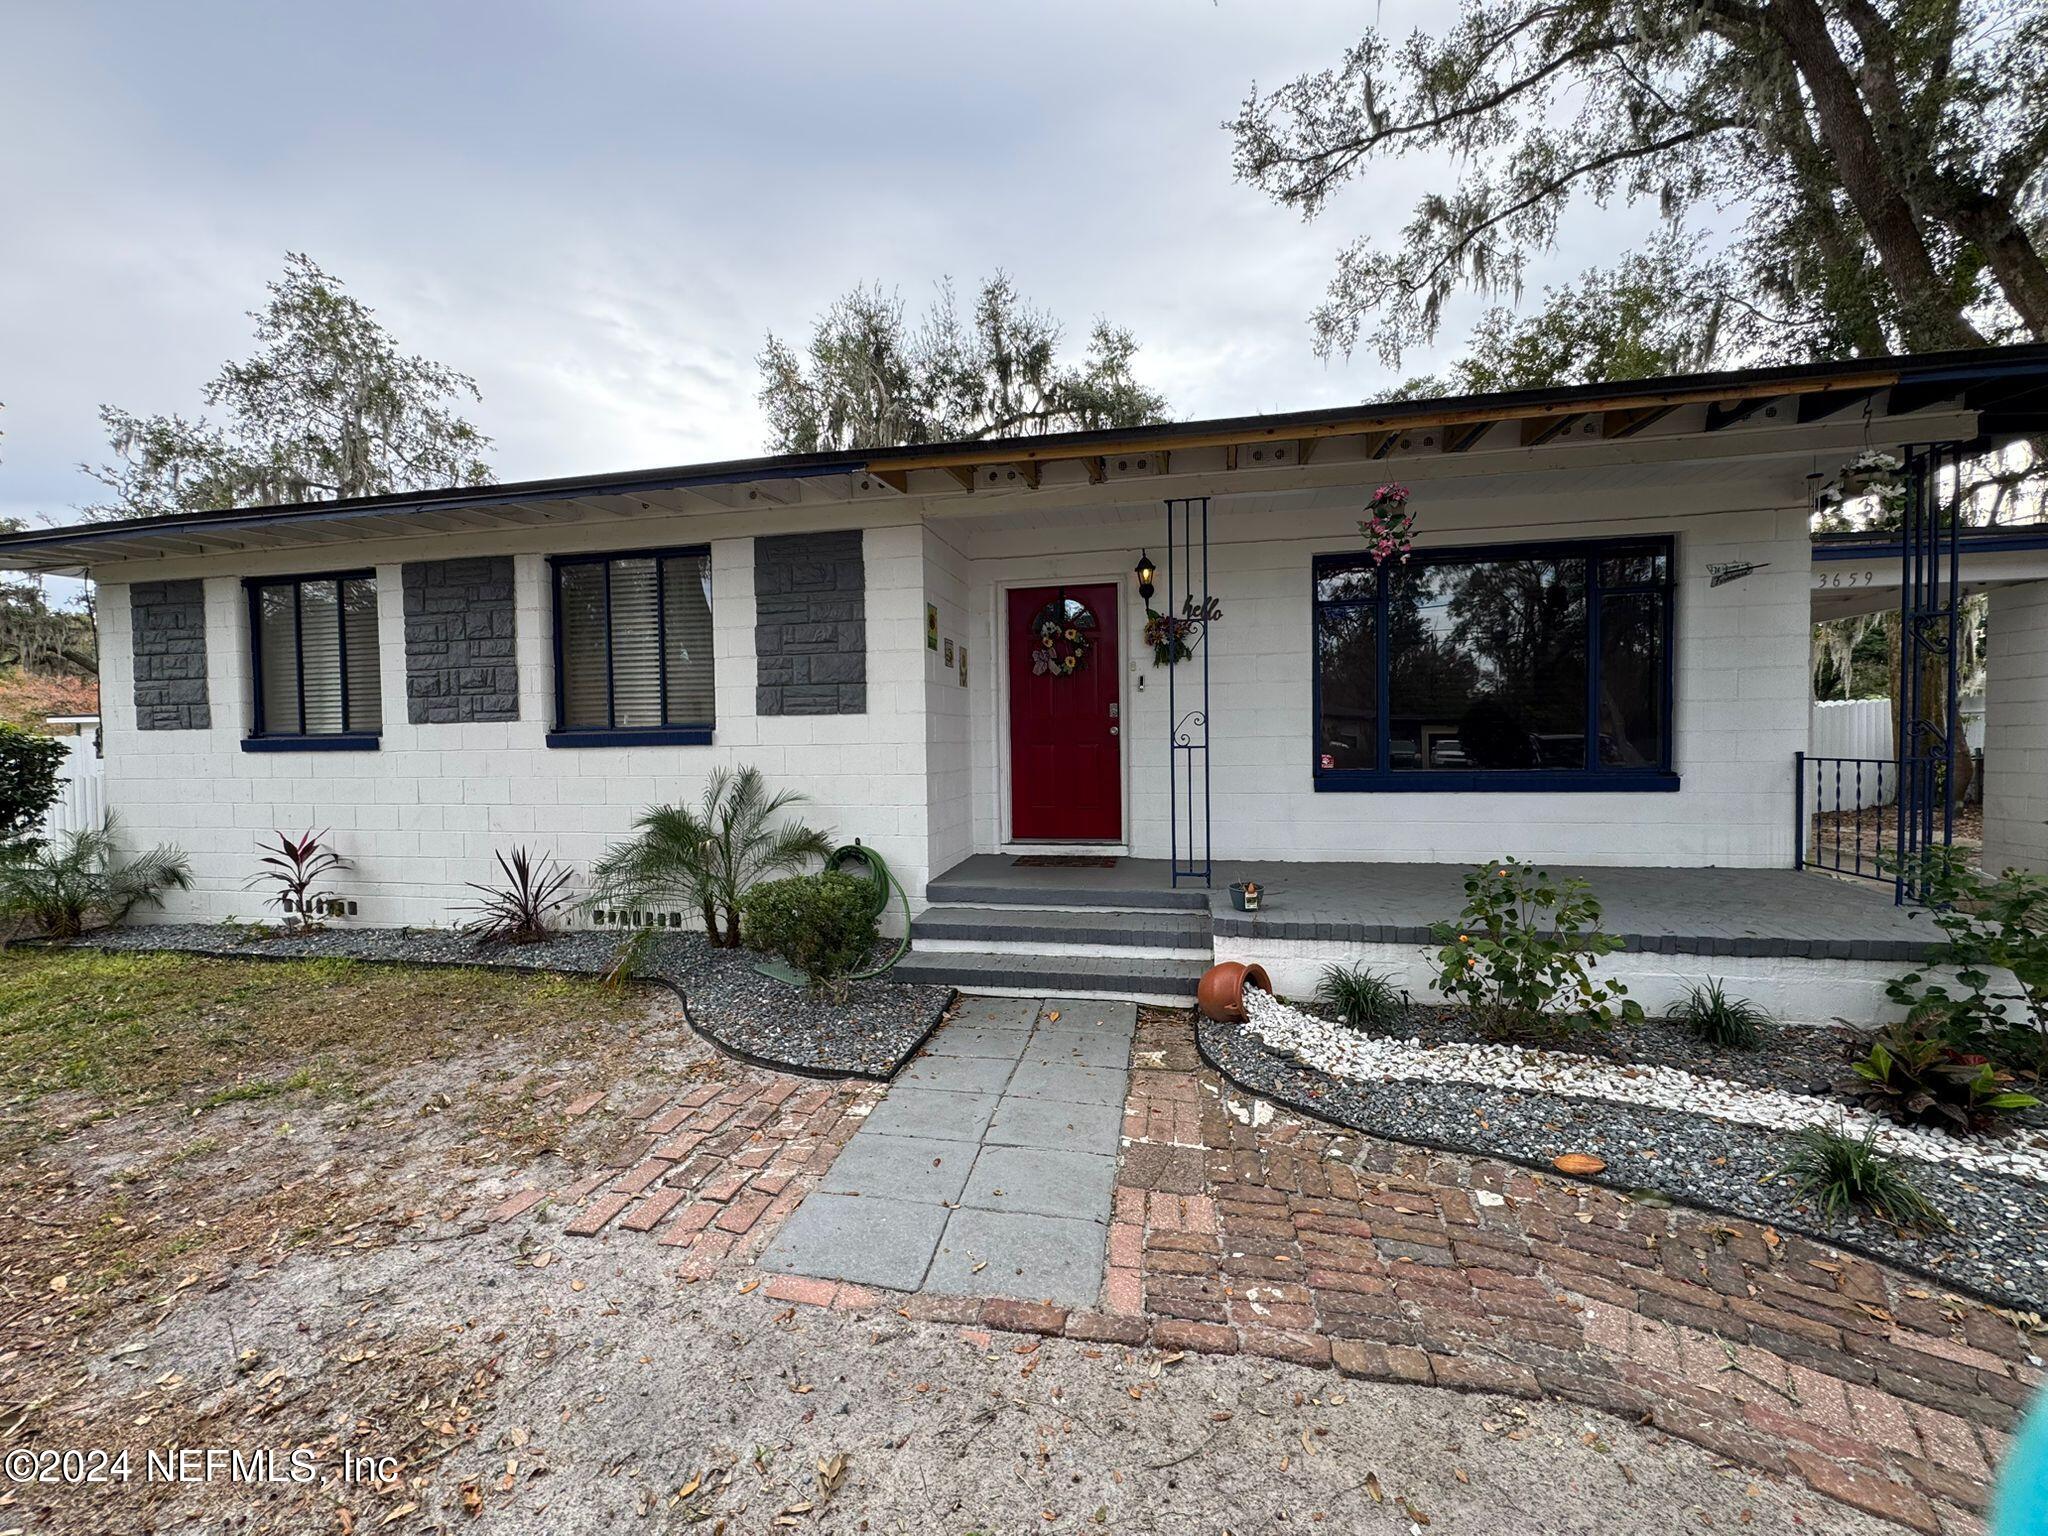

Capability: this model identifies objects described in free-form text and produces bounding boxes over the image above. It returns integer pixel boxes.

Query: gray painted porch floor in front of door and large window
[926,854,1939,961]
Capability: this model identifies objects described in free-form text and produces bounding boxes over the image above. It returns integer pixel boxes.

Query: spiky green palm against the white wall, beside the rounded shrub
[586,768,831,948]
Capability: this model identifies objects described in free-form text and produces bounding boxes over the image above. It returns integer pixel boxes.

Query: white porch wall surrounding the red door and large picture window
[961,481,1810,868]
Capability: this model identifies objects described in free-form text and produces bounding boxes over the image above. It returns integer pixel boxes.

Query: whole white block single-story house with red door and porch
[0,346,2048,1018]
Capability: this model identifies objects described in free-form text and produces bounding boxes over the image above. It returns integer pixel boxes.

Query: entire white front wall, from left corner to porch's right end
[98,465,1826,926]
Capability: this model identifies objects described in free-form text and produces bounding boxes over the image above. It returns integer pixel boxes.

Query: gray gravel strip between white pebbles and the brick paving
[1196,1018,2048,1313]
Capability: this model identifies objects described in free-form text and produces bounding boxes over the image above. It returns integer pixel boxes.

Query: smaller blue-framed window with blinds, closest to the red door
[547,549,715,748]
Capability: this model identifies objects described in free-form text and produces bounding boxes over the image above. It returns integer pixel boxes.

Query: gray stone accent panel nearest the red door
[754,528,868,715]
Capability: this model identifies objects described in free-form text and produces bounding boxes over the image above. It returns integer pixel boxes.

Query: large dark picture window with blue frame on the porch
[1313,539,1677,791]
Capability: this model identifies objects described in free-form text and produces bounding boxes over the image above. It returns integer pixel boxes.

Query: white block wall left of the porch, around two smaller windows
[98,508,930,926]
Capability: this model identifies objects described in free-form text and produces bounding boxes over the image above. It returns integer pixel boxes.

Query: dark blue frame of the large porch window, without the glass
[1309,535,1679,795]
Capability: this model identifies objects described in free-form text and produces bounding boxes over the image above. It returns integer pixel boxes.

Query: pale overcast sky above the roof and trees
[0,0,1642,548]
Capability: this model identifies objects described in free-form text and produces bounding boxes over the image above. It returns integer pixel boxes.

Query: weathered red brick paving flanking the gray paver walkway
[512,1014,2048,1534]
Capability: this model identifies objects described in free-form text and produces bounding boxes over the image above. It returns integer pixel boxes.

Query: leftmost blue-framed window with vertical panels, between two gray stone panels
[244,571,383,745]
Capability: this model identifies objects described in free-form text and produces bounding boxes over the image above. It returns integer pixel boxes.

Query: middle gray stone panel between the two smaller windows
[401,555,518,725]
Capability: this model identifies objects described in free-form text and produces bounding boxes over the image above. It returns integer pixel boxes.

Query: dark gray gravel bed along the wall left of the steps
[59,924,952,1081]
